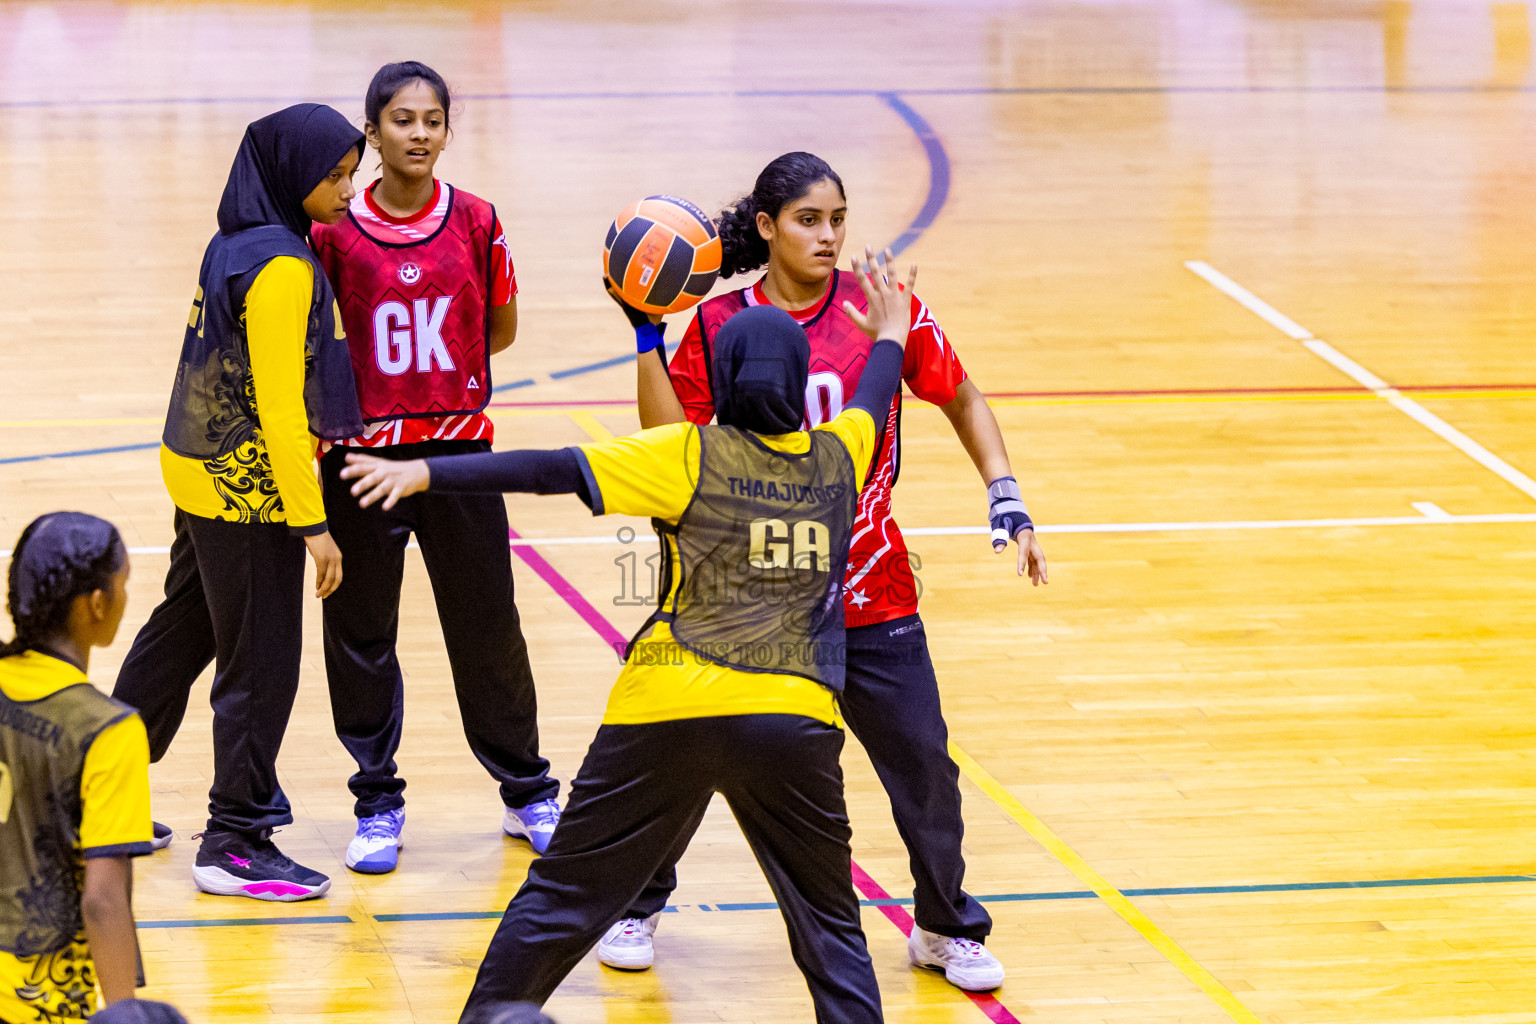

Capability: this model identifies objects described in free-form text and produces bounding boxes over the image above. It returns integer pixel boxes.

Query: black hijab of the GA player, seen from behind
[710,306,811,434]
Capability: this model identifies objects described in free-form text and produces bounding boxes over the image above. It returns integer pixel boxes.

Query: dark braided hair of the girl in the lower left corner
[0,511,127,657]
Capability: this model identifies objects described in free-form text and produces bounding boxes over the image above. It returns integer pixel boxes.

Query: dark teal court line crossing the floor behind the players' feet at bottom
[138,875,1536,929]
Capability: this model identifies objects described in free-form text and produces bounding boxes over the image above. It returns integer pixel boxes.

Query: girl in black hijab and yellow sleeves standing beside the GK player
[114,103,362,901]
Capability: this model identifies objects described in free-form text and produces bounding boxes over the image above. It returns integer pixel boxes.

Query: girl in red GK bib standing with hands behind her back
[315,61,559,874]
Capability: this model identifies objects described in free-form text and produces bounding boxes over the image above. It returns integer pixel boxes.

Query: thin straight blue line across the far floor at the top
[12,84,1536,109]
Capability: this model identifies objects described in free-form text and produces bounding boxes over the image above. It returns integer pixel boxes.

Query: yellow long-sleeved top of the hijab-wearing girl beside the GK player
[160,256,326,536]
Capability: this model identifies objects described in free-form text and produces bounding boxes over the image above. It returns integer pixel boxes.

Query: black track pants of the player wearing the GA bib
[462,715,882,1024]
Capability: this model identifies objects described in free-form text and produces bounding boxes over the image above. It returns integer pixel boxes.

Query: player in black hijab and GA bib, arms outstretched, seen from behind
[341,257,915,1024]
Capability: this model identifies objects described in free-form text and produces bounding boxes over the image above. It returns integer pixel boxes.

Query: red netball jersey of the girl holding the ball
[668,270,966,626]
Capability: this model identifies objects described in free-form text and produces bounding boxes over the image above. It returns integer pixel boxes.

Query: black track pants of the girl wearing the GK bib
[319,441,559,818]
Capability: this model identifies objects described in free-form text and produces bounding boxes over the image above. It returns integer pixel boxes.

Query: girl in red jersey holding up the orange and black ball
[617,154,1046,990]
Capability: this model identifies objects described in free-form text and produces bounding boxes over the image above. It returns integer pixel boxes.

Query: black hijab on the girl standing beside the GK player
[218,103,362,238]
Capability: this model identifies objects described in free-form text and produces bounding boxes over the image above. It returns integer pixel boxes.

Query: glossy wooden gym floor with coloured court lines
[0,0,1536,1024]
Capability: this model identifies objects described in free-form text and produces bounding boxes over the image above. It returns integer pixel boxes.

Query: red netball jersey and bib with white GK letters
[312,186,505,444]
